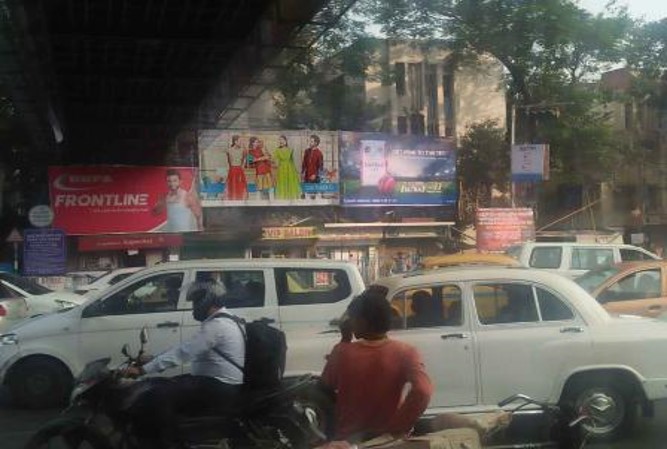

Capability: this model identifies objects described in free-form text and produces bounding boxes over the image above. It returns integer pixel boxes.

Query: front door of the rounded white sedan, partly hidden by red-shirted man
[391,284,478,408]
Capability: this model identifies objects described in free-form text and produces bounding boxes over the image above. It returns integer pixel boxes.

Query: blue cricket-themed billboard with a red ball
[339,132,458,206]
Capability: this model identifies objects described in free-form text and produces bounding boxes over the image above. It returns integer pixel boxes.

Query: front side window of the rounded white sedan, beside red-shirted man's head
[391,285,463,329]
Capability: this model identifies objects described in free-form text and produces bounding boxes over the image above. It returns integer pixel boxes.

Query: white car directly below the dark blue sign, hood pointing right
[0,272,86,316]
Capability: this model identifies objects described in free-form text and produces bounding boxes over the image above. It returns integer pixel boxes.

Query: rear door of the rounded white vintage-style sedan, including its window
[470,280,592,405]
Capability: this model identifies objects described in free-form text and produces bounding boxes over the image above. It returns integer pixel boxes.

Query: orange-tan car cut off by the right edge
[575,260,667,317]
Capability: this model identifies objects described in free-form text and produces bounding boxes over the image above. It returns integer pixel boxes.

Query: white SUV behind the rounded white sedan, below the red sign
[506,242,660,278]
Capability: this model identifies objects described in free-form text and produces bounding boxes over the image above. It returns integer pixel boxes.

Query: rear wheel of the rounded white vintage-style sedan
[569,380,637,441]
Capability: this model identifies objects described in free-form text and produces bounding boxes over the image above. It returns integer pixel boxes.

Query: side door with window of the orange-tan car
[594,268,667,317]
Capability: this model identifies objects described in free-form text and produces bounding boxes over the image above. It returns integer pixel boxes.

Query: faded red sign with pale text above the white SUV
[476,208,535,252]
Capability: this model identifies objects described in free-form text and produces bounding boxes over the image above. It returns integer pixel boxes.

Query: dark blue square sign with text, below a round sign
[23,228,67,276]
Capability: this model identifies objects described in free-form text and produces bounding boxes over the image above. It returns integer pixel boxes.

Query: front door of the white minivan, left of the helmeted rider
[79,270,189,376]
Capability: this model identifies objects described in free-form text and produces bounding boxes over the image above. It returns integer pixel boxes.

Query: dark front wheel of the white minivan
[7,357,72,409]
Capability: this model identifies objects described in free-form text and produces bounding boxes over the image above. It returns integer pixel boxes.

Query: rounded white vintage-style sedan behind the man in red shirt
[288,266,667,438]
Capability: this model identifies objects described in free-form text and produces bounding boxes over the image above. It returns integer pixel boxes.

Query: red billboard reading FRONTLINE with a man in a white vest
[49,166,203,235]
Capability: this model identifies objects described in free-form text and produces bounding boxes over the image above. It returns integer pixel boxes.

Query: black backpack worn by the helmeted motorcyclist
[213,313,287,390]
